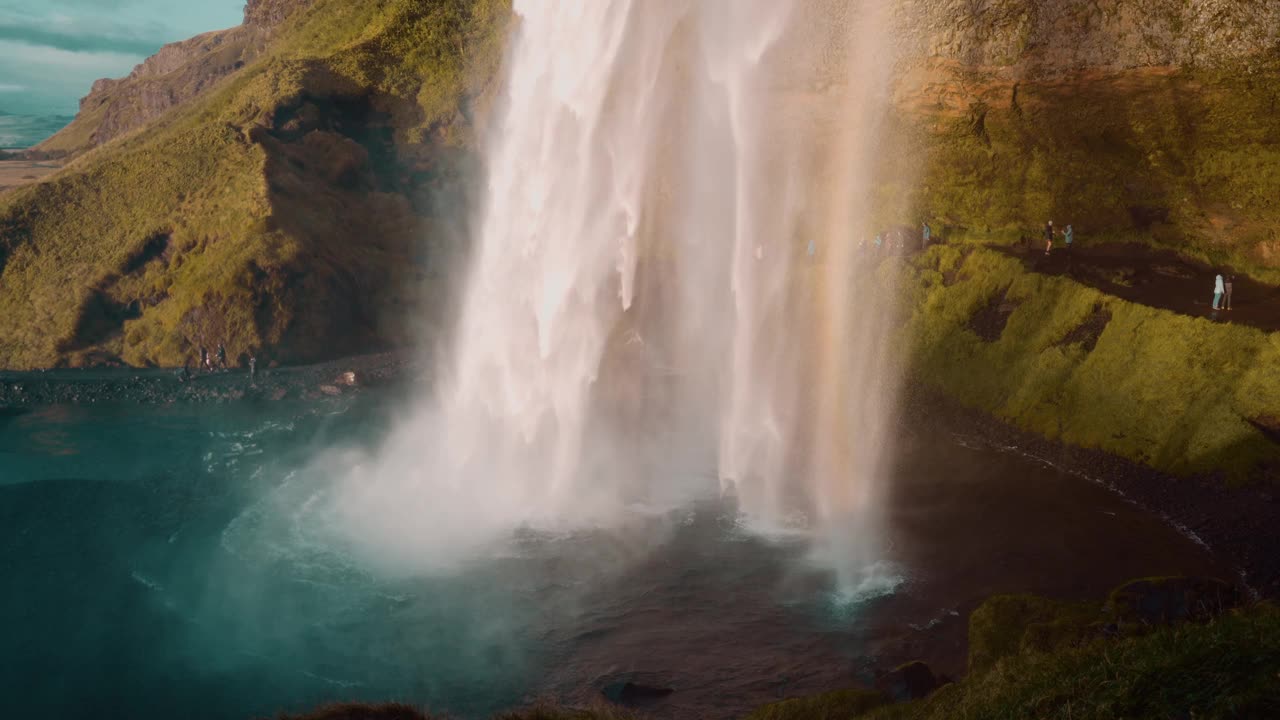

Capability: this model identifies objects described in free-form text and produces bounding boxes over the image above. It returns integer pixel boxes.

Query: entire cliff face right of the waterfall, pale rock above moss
[883,0,1280,271]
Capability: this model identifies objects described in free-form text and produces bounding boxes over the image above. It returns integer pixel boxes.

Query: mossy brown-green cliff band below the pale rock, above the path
[878,51,1280,282]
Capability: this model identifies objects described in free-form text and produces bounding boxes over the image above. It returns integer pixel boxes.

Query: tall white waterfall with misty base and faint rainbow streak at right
[327,0,893,584]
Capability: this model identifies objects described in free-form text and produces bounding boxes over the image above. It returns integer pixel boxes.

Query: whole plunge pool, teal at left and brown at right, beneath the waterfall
[0,392,1229,719]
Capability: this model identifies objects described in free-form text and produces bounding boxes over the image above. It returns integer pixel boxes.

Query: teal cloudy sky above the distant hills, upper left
[0,0,244,147]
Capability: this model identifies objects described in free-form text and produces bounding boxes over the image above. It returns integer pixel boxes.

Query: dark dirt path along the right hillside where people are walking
[988,243,1280,332]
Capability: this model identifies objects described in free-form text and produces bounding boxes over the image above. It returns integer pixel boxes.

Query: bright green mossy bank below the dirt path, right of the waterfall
[900,243,1280,480]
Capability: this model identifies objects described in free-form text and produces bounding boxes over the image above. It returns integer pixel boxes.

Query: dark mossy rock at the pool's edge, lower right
[1106,578,1242,625]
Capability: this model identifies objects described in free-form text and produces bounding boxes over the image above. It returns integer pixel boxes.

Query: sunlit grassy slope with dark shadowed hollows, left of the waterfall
[0,0,507,368]
